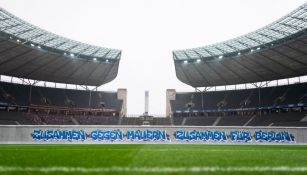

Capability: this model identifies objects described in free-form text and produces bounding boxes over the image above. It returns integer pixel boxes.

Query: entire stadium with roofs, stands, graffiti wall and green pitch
[0,0,307,174]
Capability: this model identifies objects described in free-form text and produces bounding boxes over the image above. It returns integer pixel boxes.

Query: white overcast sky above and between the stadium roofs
[0,0,305,114]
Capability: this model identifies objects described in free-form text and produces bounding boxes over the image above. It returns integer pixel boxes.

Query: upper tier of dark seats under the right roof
[171,83,307,112]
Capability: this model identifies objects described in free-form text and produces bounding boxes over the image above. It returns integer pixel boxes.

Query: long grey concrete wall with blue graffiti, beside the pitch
[0,125,307,144]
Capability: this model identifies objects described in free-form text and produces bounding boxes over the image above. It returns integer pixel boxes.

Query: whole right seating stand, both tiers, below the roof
[171,83,307,126]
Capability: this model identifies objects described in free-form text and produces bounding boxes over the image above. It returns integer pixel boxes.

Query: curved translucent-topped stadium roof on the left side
[0,8,121,86]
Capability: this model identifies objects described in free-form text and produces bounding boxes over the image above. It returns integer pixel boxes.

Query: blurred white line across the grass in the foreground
[0,166,307,173]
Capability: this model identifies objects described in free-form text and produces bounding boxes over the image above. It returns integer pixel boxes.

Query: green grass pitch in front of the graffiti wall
[0,144,307,175]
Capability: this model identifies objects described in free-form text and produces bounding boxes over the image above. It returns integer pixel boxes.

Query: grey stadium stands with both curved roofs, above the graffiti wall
[0,4,307,131]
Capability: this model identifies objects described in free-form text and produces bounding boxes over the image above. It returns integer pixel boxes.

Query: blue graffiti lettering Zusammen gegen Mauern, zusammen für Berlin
[31,129,295,143]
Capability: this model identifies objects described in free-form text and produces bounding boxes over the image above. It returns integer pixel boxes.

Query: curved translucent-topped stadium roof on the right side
[173,3,307,87]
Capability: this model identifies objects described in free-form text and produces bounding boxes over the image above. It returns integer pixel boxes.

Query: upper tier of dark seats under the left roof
[0,82,122,111]
